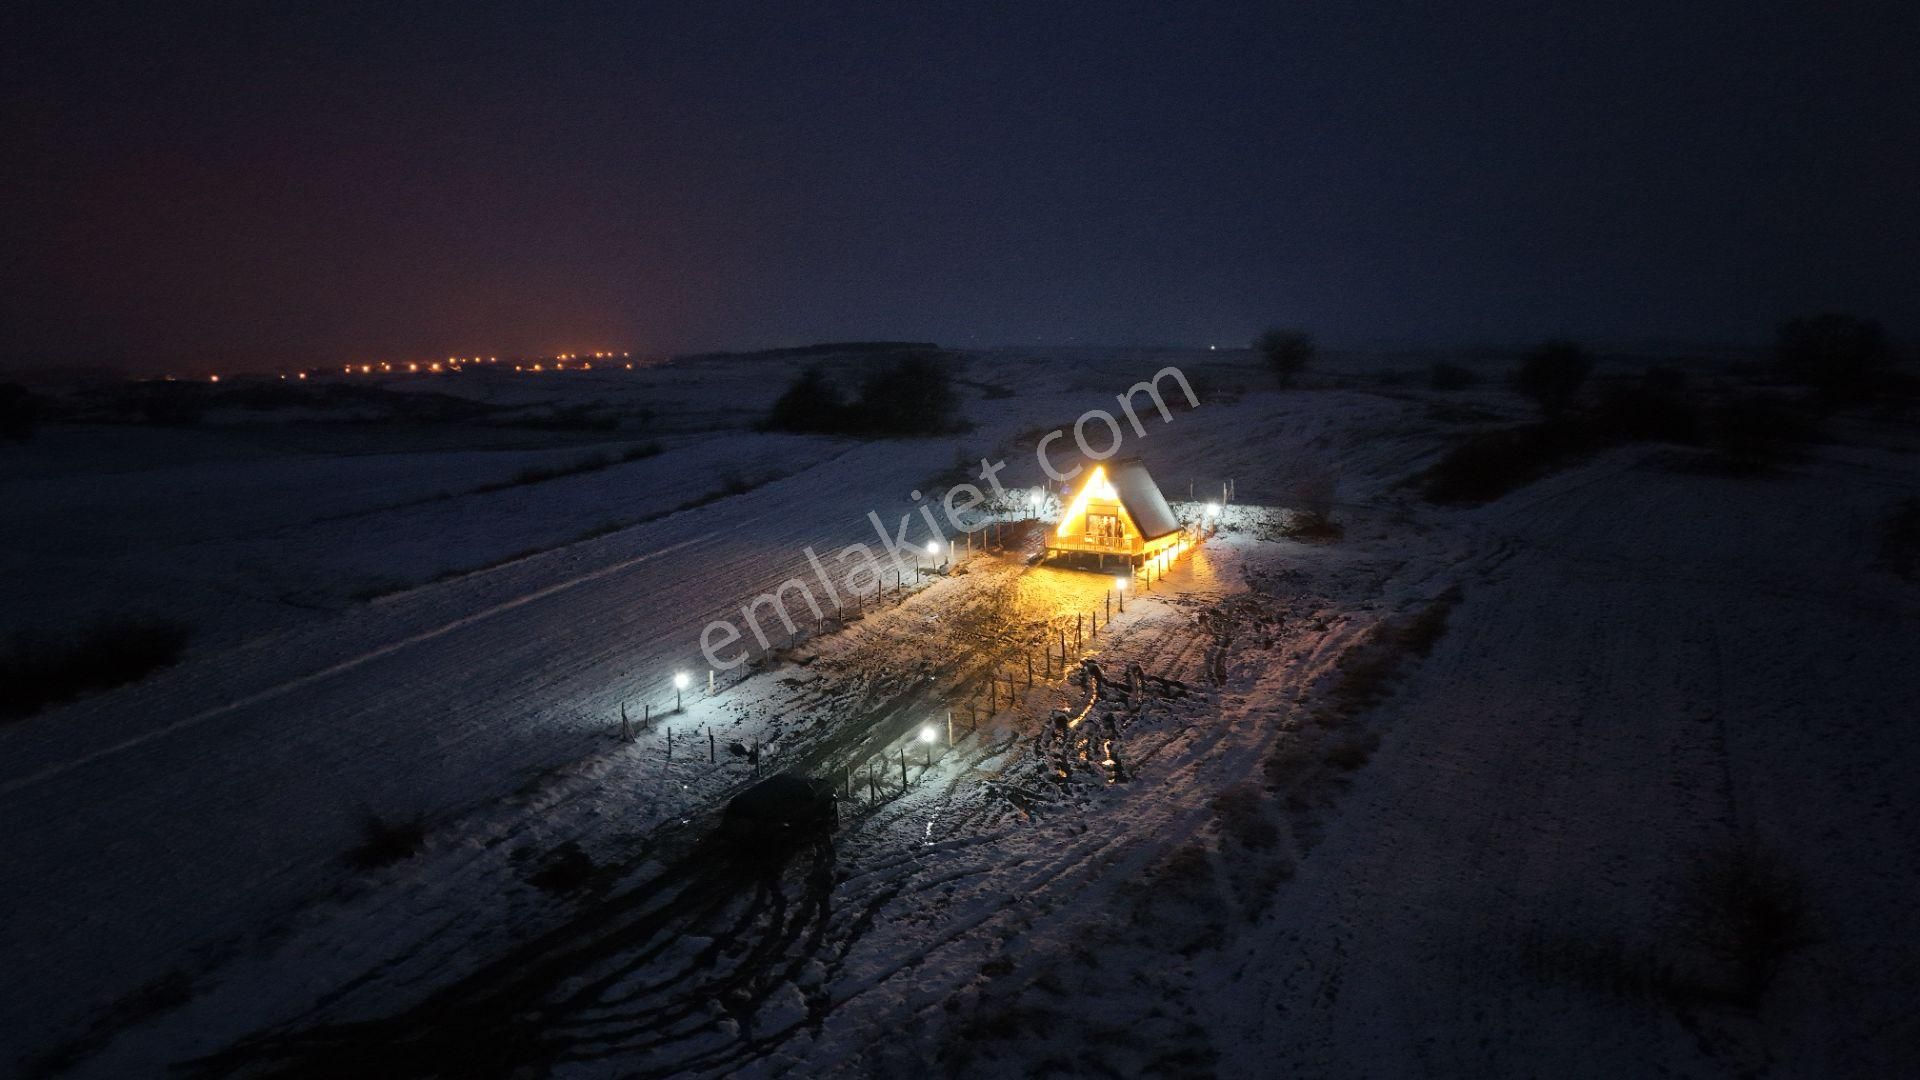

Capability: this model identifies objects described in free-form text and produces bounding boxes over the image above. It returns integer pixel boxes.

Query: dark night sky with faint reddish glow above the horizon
[0,0,1920,365]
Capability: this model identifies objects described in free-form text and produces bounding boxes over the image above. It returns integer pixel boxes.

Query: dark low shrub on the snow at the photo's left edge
[0,617,192,721]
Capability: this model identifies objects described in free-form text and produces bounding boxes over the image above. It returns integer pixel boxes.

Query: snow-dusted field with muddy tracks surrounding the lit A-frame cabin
[0,350,1920,1076]
